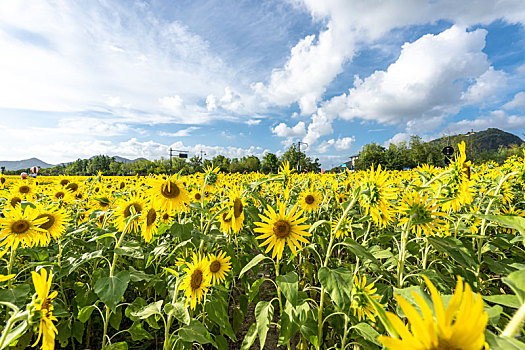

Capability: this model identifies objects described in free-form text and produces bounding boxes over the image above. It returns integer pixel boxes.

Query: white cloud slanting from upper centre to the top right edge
[253,0,525,114]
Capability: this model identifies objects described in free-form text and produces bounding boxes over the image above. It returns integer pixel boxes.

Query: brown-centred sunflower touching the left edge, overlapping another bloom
[0,204,49,250]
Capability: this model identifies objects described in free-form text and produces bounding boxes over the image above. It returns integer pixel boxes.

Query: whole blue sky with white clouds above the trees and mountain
[0,0,525,167]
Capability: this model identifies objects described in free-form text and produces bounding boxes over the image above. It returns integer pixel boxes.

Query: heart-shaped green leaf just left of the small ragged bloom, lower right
[318,266,354,308]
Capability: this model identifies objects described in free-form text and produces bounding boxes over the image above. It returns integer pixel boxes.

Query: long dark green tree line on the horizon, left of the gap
[2,146,321,176]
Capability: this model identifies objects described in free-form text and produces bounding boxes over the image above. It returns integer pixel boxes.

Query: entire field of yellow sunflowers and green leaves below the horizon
[0,144,525,350]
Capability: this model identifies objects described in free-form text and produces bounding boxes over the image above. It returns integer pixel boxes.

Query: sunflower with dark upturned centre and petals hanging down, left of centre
[148,176,190,213]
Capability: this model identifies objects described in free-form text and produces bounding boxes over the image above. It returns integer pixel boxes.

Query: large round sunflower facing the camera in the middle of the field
[254,203,312,260]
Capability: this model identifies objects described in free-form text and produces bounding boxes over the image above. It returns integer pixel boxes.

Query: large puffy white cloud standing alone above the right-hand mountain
[323,26,494,127]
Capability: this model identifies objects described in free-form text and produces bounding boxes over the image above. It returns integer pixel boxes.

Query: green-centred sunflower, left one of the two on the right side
[359,165,396,227]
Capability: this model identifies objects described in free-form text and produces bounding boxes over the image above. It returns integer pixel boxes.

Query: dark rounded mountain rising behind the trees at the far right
[429,128,523,152]
